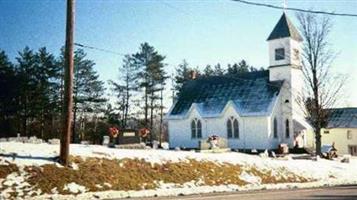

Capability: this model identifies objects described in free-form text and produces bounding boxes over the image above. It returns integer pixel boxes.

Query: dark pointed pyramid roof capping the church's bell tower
[267,13,303,41]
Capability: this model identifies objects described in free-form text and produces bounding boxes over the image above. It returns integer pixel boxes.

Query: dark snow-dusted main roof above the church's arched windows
[169,71,283,117]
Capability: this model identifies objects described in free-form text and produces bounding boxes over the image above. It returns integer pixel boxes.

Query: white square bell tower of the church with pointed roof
[267,12,304,144]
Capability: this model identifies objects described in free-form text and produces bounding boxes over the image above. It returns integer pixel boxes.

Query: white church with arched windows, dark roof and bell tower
[166,13,311,149]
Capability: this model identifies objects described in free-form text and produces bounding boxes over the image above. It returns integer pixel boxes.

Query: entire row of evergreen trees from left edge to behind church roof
[0,43,261,143]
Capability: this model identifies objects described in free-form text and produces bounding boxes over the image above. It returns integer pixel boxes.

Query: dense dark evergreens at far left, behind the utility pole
[0,47,107,141]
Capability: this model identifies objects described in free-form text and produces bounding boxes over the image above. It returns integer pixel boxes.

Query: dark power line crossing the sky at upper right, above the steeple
[232,0,357,17]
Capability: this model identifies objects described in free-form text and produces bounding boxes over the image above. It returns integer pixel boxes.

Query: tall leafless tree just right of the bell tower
[297,13,344,155]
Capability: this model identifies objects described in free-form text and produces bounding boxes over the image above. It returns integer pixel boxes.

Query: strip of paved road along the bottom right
[133,185,357,200]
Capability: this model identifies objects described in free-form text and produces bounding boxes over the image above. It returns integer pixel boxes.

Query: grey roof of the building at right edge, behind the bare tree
[327,108,357,128]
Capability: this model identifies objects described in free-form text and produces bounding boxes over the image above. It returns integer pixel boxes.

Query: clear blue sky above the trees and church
[0,0,357,106]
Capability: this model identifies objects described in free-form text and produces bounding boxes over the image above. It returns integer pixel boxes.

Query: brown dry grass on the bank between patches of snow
[21,157,308,194]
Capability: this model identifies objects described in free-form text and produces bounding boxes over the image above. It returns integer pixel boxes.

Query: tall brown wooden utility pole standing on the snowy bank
[60,0,75,166]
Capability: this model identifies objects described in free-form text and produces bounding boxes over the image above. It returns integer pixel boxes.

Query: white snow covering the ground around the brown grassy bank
[0,142,357,199]
